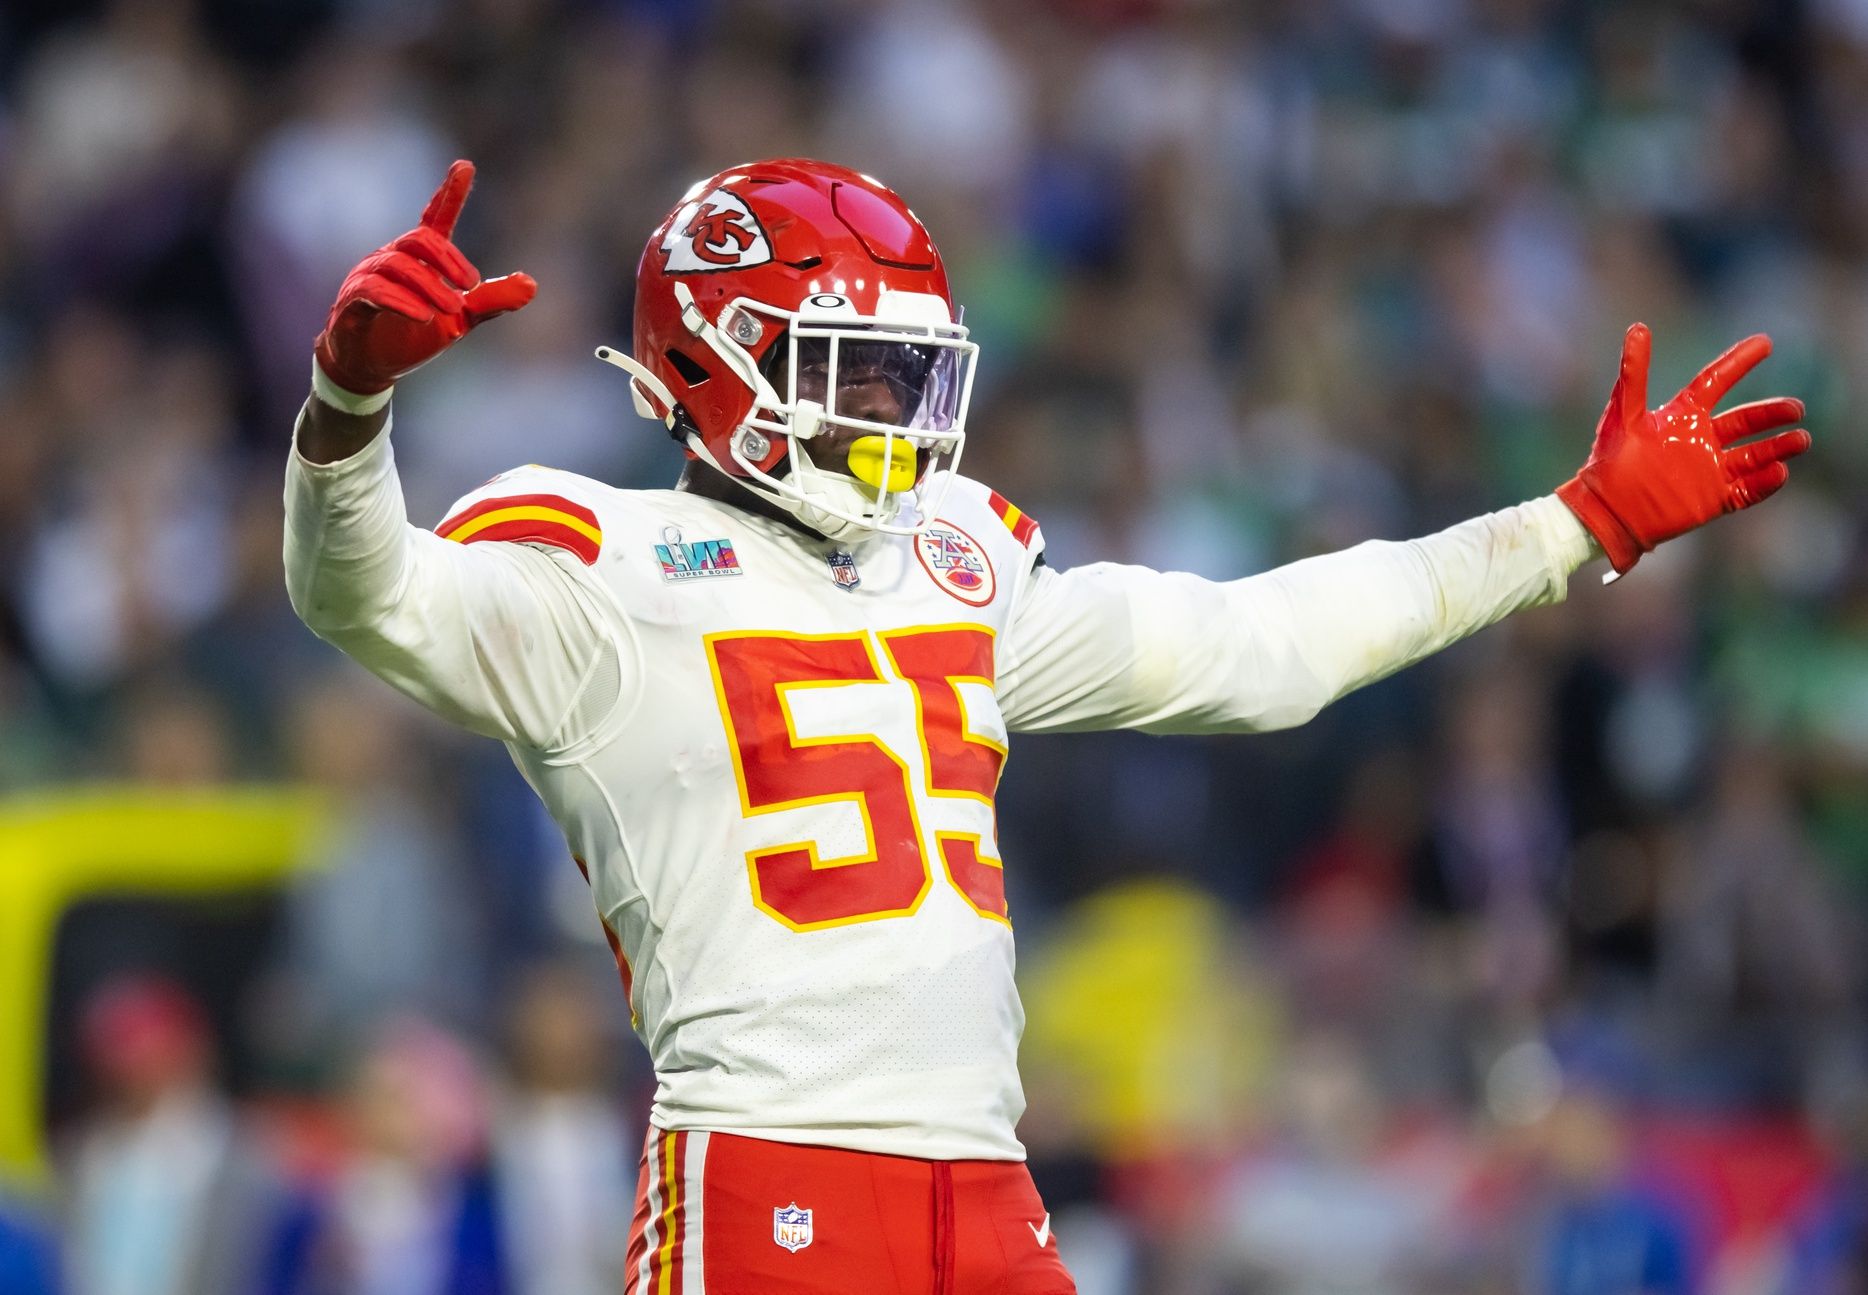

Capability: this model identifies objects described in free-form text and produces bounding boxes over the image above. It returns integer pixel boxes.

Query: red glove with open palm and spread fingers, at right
[1556,323,1810,574]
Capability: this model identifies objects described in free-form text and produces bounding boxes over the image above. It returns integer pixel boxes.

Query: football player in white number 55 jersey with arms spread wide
[286,159,1810,1295]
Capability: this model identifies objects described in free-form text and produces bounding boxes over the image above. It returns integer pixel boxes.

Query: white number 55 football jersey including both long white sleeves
[286,409,1592,1159]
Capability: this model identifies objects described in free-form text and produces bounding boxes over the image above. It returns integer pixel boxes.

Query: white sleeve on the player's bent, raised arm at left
[286,403,618,749]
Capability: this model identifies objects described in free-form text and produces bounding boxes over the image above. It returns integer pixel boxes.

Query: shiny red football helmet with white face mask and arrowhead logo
[598,157,979,538]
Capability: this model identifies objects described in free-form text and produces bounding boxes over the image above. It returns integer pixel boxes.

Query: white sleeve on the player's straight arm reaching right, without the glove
[998,495,1597,733]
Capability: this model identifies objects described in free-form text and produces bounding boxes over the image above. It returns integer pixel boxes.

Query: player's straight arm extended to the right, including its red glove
[999,325,1810,733]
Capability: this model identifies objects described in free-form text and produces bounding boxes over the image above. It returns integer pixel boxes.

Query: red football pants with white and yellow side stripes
[624,1129,1076,1295]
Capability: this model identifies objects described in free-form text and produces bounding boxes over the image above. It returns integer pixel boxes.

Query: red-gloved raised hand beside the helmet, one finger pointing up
[314,161,538,396]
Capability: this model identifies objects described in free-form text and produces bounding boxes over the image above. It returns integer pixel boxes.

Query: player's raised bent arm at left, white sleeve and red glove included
[286,163,618,747]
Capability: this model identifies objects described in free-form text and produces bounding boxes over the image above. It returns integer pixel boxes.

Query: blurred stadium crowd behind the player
[0,0,1868,1295]
